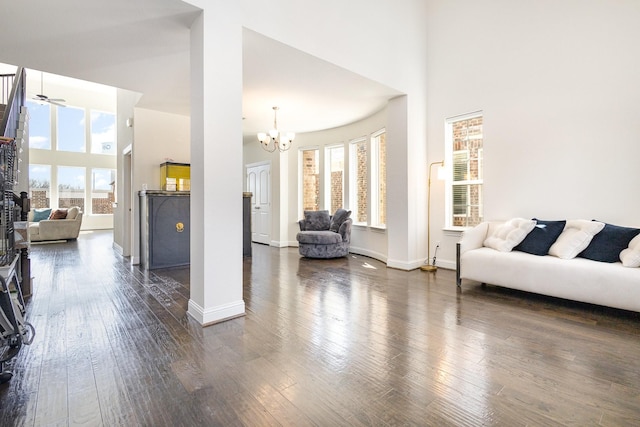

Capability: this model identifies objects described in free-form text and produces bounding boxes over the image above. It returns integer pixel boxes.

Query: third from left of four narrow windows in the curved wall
[349,138,369,224]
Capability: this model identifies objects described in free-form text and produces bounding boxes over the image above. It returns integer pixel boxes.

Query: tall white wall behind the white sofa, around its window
[425,0,640,266]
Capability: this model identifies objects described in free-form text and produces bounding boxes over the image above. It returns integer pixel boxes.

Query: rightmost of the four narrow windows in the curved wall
[371,129,387,227]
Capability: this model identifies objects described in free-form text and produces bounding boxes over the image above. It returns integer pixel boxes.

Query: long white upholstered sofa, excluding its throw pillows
[456,222,640,311]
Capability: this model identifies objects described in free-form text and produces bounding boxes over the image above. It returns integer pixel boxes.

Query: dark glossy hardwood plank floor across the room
[0,232,640,426]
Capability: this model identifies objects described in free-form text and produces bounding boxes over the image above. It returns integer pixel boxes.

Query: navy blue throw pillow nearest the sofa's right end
[578,220,640,262]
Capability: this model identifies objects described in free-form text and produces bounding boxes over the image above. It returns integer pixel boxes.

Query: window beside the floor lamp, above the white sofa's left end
[445,111,483,227]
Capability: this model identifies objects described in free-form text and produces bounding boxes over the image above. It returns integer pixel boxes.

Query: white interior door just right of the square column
[247,164,271,245]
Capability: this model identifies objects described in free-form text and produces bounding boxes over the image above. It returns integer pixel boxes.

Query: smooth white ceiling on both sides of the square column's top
[0,0,399,133]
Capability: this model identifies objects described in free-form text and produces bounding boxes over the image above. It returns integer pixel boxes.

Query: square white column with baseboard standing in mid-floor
[188,6,245,325]
